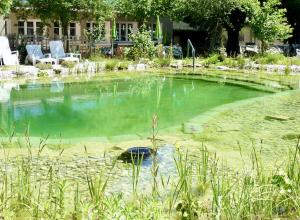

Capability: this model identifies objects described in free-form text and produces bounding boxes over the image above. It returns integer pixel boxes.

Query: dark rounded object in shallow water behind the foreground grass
[118,147,154,163]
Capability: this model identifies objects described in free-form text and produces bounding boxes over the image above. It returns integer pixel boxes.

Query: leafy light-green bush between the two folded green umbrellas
[125,30,156,60]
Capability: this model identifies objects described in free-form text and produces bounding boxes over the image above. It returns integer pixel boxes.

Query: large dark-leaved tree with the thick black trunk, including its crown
[177,0,257,56]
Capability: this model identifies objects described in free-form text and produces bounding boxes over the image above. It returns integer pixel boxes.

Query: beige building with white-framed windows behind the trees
[0,8,255,57]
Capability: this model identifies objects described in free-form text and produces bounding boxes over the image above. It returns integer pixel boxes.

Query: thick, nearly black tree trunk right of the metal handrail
[226,28,241,57]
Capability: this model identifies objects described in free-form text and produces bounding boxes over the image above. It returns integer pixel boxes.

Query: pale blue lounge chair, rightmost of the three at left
[49,40,81,63]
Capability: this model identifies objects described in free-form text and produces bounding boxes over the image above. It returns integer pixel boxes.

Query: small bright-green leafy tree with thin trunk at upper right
[250,0,292,53]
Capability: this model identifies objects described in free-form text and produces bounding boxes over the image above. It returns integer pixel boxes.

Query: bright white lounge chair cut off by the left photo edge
[0,37,19,66]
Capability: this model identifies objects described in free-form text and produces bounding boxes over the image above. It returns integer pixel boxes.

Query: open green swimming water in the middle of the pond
[0,77,266,138]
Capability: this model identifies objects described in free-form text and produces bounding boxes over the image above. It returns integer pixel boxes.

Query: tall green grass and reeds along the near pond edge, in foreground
[0,129,300,219]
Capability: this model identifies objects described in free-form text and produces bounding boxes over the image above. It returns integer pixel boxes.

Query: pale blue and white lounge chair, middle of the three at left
[25,44,56,65]
